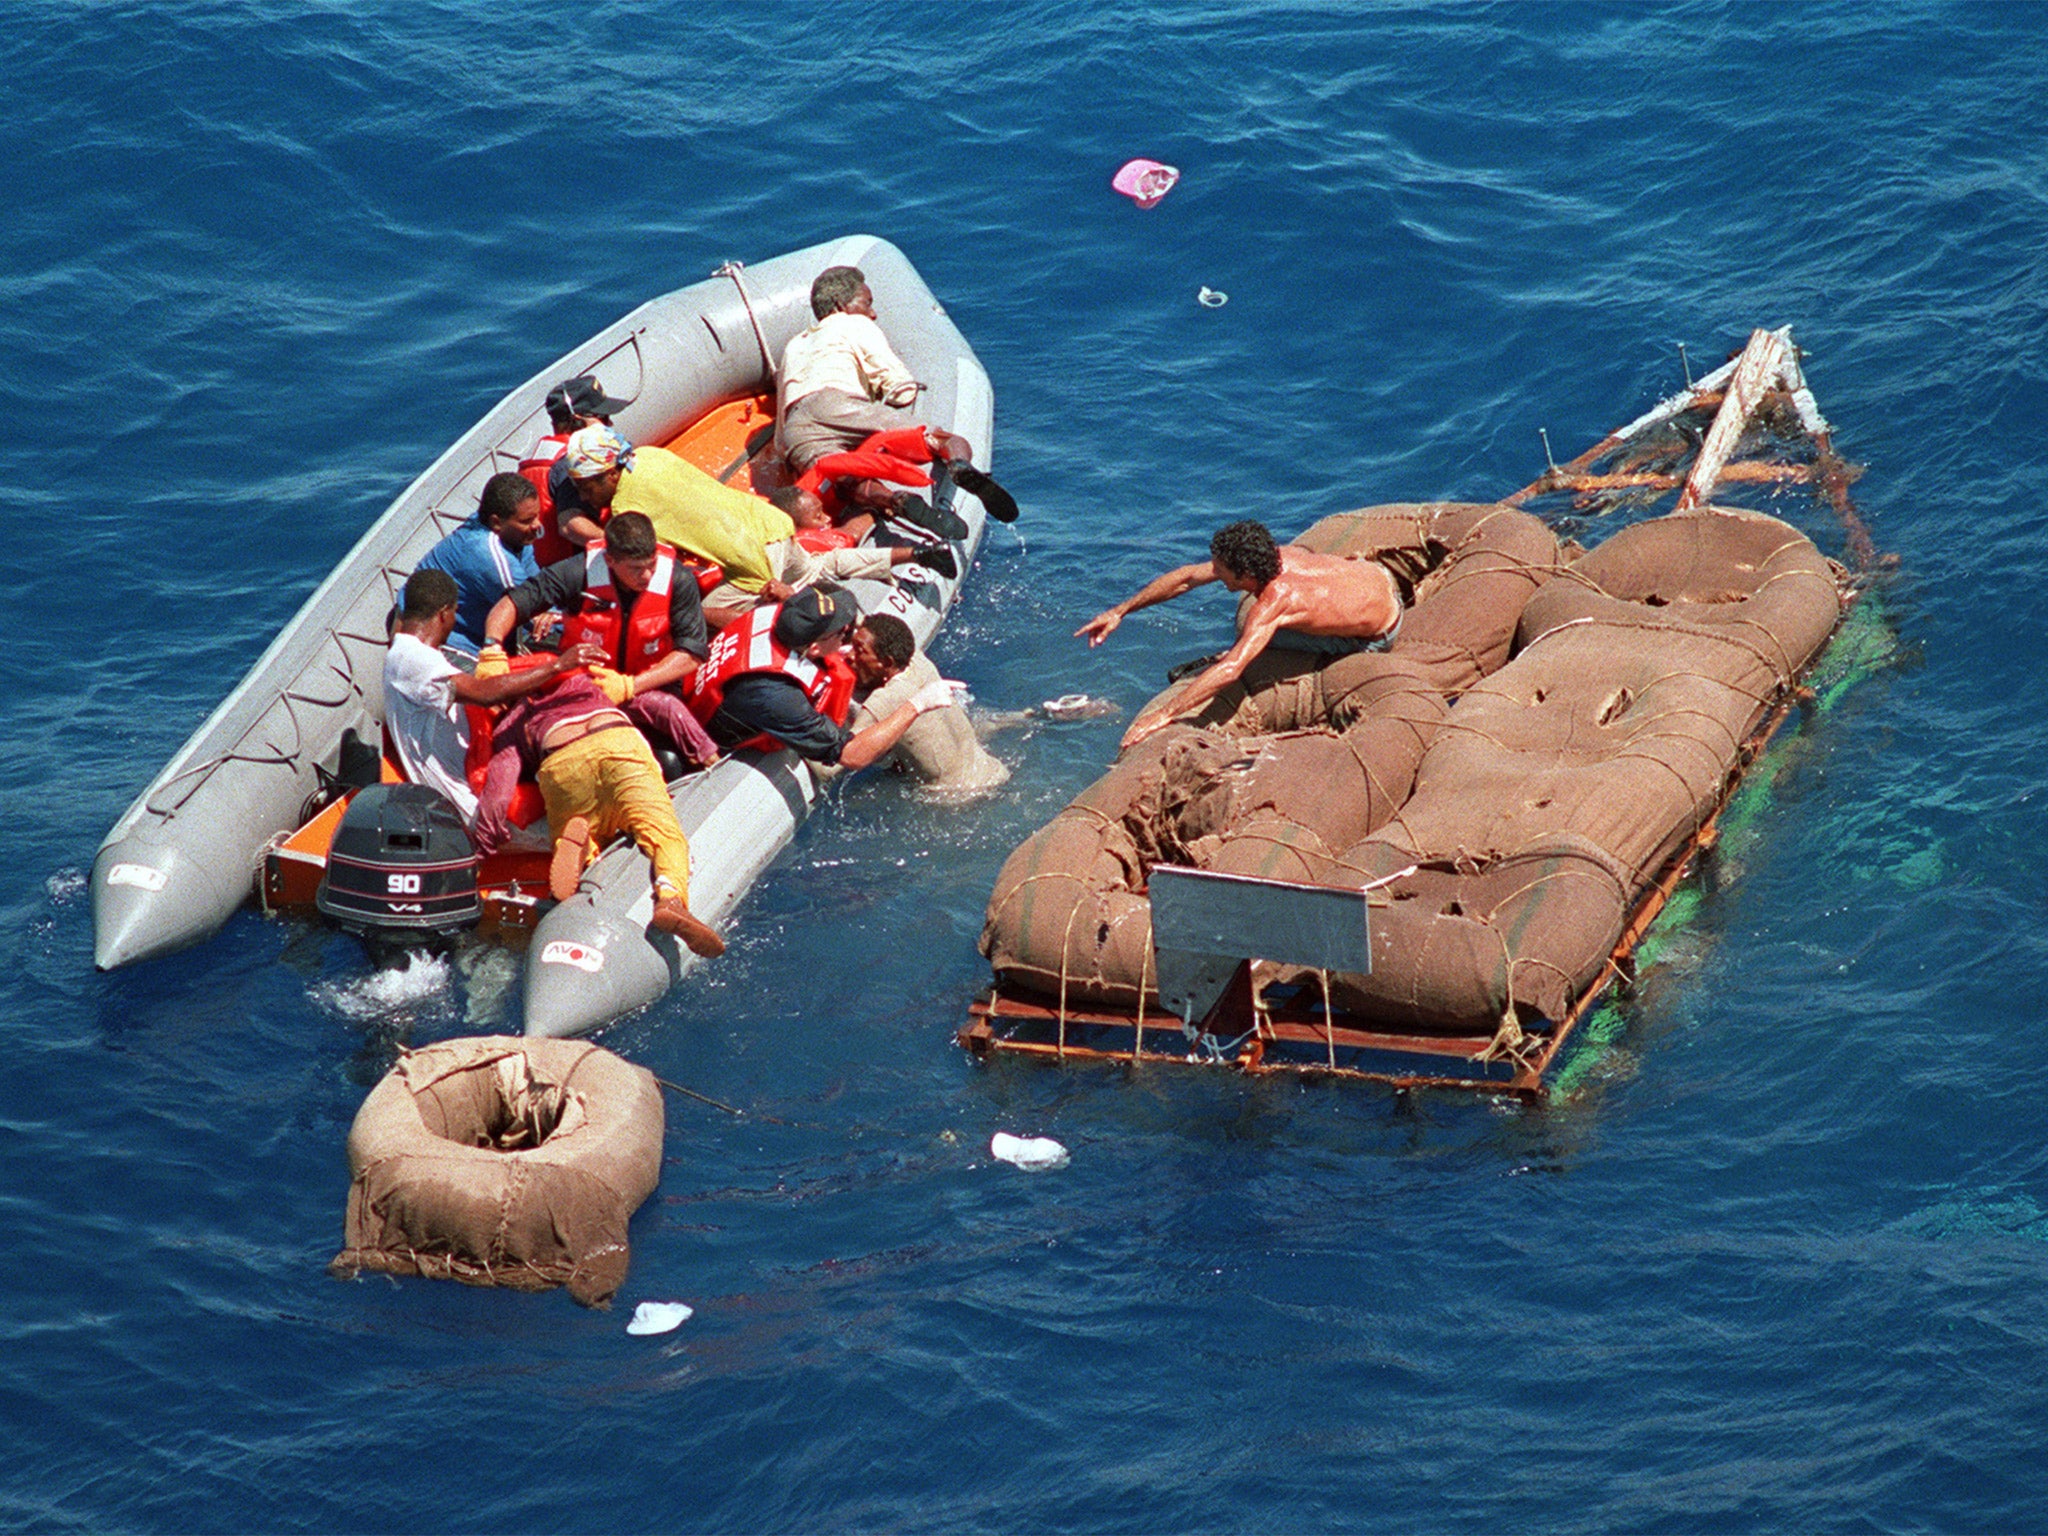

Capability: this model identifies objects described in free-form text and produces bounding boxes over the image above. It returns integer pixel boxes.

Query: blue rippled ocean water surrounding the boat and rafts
[0,0,2048,1532]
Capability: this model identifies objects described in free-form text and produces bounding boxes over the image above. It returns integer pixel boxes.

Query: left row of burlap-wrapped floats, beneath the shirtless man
[981,504,1559,1008]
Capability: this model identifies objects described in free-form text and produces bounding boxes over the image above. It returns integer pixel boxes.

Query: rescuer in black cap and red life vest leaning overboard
[688,586,952,770]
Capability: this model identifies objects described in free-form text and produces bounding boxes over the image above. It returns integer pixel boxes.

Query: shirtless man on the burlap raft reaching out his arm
[1073,522,1401,750]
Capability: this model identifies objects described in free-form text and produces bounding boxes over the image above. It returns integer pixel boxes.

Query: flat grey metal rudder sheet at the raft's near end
[1149,864,1372,1024]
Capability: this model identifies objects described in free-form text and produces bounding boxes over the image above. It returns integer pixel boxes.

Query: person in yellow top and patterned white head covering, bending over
[563,426,958,629]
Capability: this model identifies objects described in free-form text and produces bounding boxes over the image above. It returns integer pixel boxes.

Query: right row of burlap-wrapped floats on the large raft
[1333,510,1841,1040]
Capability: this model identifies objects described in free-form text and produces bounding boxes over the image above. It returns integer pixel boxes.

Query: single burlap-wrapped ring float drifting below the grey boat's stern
[330,1036,664,1307]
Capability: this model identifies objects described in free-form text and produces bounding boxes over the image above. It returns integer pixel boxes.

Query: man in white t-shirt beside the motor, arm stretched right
[383,567,604,825]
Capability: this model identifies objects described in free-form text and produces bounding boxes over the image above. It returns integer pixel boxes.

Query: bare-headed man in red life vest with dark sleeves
[483,512,717,762]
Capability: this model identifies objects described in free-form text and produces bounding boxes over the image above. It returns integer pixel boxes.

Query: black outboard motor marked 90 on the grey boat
[313,784,483,954]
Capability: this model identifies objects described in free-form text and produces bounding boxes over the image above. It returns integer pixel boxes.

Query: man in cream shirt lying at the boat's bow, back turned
[778,266,1018,537]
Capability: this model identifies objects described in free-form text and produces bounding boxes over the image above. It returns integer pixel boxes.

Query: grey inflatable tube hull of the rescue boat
[92,236,995,1036]
